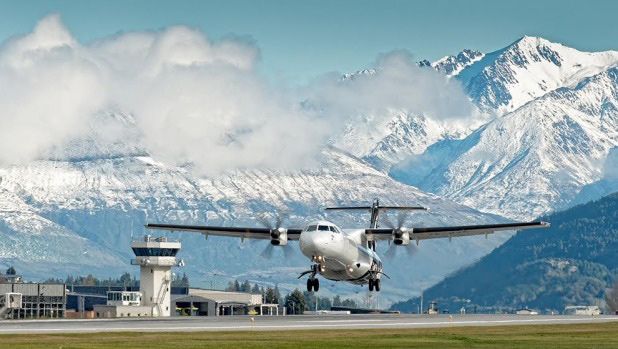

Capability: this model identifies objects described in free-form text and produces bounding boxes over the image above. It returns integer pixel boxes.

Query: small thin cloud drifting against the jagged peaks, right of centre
[309,50,476,119]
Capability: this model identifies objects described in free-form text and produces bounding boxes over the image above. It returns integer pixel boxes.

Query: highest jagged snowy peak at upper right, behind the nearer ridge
[456,36,618,114]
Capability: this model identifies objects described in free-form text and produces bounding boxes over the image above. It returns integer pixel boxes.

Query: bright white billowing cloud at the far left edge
[0,15,106,163]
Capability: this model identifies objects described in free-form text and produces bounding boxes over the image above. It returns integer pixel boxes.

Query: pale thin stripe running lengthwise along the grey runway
[0,318,618,333]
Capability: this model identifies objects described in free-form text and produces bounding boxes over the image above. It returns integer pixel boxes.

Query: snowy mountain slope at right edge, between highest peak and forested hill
[393,64,618,219]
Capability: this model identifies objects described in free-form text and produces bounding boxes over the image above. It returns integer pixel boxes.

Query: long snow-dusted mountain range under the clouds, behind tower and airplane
[0,113,509,301]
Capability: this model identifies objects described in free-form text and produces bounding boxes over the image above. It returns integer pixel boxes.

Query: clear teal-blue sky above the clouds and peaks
[0,0,618,82]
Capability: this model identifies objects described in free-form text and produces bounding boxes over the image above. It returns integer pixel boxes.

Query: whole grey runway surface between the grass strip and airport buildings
[0,314,618,334]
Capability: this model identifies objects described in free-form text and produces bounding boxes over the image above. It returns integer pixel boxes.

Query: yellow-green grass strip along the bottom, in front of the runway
[0,322,618,349]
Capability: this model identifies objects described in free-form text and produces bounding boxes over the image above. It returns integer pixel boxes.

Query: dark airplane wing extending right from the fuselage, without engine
[365,222,549,240]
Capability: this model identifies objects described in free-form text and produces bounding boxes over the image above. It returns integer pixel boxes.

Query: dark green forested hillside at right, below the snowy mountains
[392,193,618,313]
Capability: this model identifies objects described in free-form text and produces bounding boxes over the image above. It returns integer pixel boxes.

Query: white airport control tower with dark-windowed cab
[131,235,183,316]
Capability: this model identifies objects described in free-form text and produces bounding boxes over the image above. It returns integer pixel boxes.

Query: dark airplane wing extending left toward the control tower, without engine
[144,224,302,240]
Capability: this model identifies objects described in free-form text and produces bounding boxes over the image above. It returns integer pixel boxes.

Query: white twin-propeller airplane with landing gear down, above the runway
[145,199,549,292]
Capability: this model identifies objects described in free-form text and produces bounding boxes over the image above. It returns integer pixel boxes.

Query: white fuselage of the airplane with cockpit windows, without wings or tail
[299,221,382,284]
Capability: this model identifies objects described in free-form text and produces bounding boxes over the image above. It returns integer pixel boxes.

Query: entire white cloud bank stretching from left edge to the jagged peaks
[0,15,472,174]
